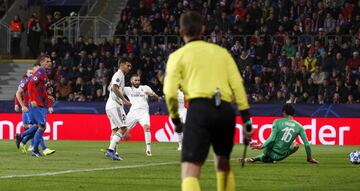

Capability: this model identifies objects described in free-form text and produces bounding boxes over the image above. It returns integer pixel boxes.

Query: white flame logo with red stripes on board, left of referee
[155,117,179,142]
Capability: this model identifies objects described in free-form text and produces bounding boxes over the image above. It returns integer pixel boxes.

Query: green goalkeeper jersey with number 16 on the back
[263,117,311,158]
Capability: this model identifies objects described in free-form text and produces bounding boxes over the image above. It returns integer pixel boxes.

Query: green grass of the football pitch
[0,141,360,191]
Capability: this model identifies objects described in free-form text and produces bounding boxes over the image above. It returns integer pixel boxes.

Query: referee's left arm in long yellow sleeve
[164,54,181,119]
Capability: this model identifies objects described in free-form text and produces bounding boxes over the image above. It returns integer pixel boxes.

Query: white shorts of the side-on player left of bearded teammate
[106,107,126,129]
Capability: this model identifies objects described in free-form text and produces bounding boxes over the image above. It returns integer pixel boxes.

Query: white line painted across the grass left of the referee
[0,162,180,179]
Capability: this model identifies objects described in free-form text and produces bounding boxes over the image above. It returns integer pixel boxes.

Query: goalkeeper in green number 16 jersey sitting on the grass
[239,104,319,164]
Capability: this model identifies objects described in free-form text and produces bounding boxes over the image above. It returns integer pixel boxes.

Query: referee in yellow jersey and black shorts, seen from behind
[164,11,252,191]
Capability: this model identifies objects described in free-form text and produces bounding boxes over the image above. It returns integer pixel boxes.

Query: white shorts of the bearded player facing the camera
[126,109,150,130]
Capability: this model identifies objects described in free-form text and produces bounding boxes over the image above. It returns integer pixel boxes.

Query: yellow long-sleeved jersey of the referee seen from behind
[164,40,249,118]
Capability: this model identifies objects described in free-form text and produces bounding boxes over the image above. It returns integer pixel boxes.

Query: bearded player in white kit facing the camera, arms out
[124,74,159,156]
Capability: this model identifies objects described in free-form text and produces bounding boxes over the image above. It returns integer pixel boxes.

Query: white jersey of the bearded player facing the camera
[124,85,154,111]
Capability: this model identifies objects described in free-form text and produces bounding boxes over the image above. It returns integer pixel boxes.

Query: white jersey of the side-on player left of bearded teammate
[105,70,125,109]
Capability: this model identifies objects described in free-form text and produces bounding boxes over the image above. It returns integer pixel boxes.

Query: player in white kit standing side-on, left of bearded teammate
[105,58,131,160]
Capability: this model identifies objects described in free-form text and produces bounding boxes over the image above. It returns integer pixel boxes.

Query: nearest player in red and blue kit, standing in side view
[24,55,54,157]
